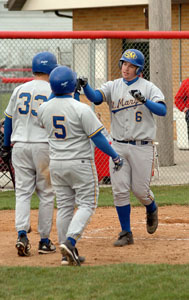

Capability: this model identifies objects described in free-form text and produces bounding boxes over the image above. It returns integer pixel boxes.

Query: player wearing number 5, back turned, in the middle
[38,66,122,265]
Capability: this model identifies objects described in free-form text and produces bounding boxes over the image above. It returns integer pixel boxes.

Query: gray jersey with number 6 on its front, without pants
[99,78,164,140]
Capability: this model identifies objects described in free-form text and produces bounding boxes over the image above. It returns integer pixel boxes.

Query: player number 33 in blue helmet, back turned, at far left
[4,52,57,256]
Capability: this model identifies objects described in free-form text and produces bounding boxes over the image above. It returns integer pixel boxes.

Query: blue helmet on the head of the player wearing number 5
[49,66,77,95]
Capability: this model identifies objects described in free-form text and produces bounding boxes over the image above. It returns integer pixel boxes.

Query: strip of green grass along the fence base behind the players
[0,185,189,209]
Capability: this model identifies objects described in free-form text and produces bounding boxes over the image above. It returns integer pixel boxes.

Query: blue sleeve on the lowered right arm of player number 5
[91,132,118,159]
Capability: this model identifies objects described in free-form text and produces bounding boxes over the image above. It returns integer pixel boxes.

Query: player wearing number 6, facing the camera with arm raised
[80,49,166,247]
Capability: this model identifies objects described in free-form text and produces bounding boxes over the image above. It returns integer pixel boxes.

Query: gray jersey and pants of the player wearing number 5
[38,96,104,244]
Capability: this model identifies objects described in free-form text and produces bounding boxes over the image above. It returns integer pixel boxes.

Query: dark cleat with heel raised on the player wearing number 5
[60,240,80,266]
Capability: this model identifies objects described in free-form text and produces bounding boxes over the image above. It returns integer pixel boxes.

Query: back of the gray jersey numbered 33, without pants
[5,80,51,143]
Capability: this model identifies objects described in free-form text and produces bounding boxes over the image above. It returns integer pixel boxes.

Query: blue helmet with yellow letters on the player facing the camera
[119,49,145,75]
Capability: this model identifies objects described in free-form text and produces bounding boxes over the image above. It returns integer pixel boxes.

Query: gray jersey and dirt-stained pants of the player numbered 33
[5,80,54,238]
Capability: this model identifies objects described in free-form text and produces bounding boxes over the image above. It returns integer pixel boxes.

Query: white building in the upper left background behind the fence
[0,0,72,68]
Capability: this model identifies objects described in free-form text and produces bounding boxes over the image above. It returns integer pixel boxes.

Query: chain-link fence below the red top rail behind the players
[0,32,189,188]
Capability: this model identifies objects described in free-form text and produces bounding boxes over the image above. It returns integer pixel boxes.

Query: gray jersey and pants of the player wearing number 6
[99,77,164,206]
